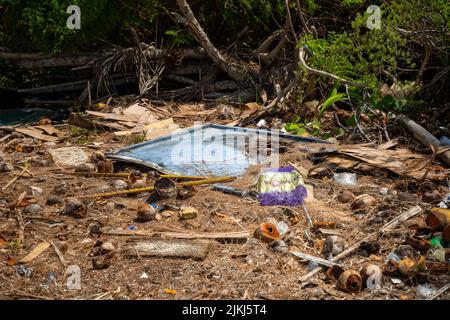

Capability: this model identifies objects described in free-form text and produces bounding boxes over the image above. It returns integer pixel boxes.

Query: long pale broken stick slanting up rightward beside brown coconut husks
[299,206,422,282]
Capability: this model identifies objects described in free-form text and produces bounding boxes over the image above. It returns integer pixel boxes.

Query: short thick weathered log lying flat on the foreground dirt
[124,239,209,260]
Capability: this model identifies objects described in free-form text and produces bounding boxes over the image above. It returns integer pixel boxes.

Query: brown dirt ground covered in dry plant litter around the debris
[0,120,450,300]
